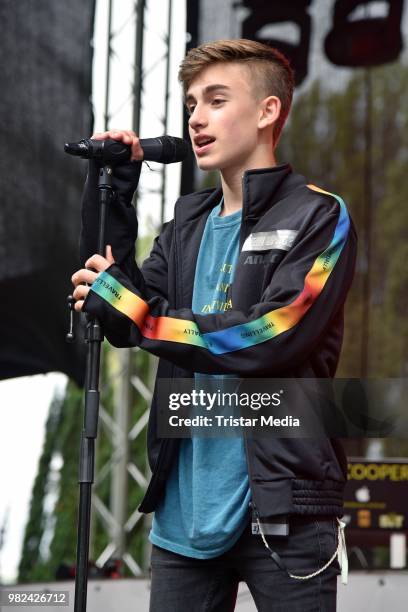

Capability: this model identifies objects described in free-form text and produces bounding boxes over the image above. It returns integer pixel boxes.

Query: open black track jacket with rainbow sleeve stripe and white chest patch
[81,162,357,519]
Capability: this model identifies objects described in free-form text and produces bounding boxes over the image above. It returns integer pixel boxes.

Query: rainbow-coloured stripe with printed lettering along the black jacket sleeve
[91,185,350,355]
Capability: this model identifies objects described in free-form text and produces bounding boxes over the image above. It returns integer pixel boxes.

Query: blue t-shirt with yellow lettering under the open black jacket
[149,203,251,559]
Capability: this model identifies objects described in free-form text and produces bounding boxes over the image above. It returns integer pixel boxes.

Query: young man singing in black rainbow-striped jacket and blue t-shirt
[72,40,356,612]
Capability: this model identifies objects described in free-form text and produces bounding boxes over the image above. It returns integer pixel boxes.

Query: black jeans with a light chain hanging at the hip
[150,517,340,612]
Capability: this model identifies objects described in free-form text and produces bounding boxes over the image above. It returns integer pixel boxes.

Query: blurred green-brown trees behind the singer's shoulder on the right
[279,64,408,378]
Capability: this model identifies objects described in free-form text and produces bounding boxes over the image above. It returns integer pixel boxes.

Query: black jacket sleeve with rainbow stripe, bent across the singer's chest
[84,191,356,376]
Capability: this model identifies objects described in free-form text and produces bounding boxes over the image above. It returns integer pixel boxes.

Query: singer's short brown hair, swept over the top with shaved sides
[178,38,294,144]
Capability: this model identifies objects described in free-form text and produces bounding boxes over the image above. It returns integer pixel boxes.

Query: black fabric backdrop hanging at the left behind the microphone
[0,0,94,384]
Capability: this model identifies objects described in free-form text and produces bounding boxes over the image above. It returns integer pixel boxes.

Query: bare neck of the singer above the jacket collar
[220,147,276,217]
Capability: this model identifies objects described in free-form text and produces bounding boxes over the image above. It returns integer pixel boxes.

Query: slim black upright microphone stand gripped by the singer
[74,164,113,612]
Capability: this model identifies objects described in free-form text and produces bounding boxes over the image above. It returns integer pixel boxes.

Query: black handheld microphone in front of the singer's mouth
[64,136,189,164]
